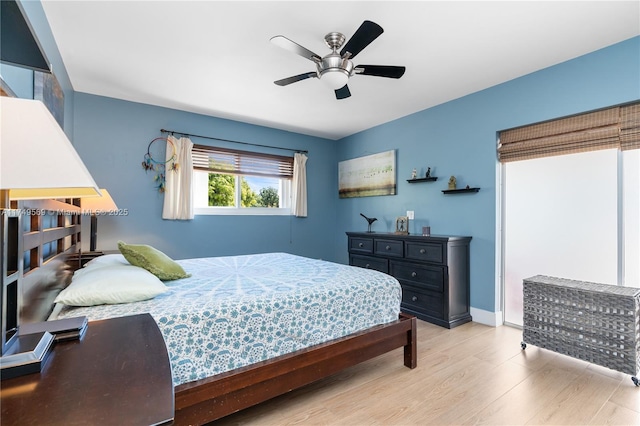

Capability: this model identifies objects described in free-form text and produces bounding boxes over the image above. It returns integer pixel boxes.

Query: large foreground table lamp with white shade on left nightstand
[0,96,100,366]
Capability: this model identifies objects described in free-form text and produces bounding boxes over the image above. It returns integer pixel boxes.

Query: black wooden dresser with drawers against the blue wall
[347,232,471,328]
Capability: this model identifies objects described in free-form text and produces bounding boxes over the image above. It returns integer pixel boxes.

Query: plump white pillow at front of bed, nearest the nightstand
[55,265,168,306]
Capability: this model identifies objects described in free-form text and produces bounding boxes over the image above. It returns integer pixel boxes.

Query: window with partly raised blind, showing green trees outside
[192,145,293,215]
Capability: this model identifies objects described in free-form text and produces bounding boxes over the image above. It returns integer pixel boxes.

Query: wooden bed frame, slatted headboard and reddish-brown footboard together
[2,198,417,425]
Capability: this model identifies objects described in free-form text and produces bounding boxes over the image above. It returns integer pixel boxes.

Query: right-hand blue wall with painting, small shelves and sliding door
[336,37,640,312]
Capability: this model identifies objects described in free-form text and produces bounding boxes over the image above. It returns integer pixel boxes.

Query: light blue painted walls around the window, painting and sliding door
[12,2,640,318]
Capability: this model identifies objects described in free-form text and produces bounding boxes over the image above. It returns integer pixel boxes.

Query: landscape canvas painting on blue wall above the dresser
[338,150,396,198]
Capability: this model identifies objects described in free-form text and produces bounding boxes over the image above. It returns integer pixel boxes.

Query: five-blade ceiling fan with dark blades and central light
[271,21,405,99]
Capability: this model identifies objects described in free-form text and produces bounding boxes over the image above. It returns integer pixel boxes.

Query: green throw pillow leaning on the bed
[118,241,191,281]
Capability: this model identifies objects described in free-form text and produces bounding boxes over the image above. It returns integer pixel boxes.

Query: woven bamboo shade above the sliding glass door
[498,103,640,163]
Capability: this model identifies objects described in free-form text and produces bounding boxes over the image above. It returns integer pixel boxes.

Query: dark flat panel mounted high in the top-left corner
[0,0,51,73]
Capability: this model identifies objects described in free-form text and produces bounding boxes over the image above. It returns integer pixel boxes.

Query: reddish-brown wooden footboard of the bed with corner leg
[174,313,417,425]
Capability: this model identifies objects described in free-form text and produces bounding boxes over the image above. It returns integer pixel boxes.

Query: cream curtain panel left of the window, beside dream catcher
[162,135,193,220]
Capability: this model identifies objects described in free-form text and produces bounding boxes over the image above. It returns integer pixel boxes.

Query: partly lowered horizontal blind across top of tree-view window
[191,145,293,179]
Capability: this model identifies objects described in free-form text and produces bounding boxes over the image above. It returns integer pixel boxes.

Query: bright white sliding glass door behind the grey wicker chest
[502,149,640,325]
